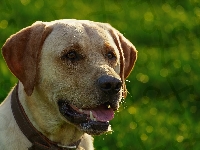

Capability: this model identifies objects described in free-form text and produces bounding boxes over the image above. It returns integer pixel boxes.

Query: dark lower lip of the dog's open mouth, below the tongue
[58,100,109,134]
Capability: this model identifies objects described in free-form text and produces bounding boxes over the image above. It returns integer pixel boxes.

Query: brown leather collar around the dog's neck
[11,84,81,150]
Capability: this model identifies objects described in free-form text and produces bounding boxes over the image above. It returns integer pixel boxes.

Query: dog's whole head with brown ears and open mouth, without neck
[2,20,137,134]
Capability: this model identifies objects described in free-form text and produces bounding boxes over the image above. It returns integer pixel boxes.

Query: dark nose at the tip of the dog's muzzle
[97,75,122,94]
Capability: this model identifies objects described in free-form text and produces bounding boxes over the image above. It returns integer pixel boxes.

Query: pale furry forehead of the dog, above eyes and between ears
[41,19,117,55]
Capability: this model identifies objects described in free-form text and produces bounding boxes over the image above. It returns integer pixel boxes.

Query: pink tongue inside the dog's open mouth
[91,106,114,122]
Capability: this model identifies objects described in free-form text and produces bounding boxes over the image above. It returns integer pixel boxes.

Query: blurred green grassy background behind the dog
[0,0,200,150]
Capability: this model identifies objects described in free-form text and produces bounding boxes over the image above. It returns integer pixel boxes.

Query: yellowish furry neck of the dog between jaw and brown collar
[14,83,83,146]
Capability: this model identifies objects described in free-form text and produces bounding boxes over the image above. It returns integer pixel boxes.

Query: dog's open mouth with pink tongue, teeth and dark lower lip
[58,100,116,135]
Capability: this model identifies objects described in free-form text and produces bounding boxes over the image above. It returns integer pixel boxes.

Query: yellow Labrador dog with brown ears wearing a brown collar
[0,19,137,150]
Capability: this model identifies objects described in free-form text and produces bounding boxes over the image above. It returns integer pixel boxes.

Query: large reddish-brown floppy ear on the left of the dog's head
[2,22,52,96]
